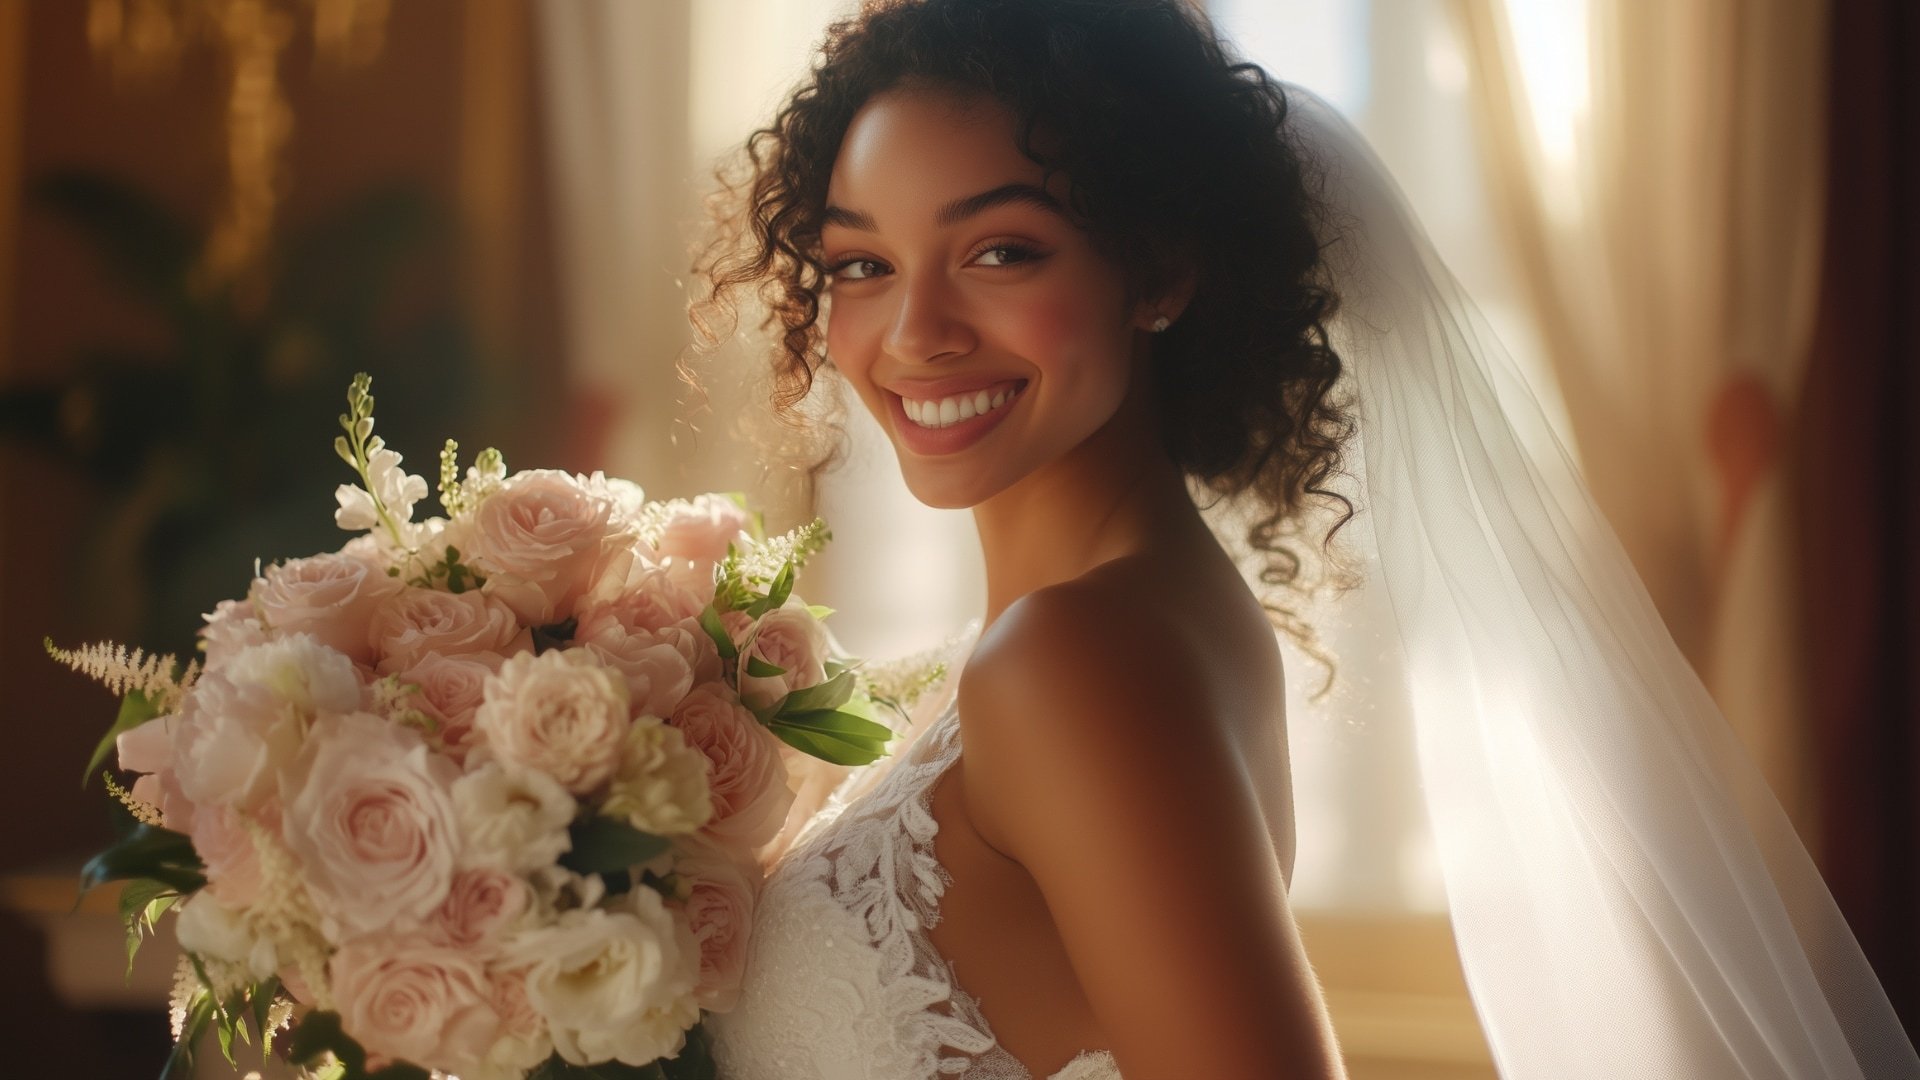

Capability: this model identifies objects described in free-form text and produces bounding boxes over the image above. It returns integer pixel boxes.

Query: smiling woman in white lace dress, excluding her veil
[699,0,1344,1080]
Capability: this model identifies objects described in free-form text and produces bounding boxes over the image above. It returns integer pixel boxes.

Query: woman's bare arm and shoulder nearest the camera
[960,588,1346,1080]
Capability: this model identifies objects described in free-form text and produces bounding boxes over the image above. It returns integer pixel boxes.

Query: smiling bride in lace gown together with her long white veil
[697,0,1920,1080]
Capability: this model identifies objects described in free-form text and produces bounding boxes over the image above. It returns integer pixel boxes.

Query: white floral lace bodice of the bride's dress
[707,680,1121,1080]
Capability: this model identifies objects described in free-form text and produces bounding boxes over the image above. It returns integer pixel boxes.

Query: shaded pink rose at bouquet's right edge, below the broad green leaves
[672,682,793,851]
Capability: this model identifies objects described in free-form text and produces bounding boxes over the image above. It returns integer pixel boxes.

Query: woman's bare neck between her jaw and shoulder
[973,357,1206,626]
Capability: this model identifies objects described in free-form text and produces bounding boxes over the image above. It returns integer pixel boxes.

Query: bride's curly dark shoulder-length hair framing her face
[691,0,1354,676]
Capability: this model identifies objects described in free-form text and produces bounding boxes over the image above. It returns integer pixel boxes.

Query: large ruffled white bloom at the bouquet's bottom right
[515,886,701,1065]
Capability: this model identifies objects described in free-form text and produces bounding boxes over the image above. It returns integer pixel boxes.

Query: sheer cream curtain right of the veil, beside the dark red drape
[1455,0,1828,844]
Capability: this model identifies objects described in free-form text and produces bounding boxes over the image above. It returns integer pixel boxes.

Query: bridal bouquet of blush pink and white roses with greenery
[48,375,913,1080]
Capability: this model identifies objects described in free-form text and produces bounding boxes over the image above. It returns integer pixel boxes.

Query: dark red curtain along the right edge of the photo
[1793,0,1920,1032]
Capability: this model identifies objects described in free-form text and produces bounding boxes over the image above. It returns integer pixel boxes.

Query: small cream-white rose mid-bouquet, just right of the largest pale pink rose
[453,761,574,872]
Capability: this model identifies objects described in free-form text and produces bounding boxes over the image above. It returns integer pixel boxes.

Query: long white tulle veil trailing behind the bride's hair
[1259,85,1920,1080]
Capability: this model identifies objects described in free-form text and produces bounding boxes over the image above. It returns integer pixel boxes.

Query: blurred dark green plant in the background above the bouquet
[0,171,497,651]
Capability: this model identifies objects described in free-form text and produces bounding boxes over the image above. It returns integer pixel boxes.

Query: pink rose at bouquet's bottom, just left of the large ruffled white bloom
[326,934,499,1070]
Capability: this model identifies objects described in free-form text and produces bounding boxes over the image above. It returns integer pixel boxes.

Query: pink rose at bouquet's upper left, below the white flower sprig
[250,553,405,663]
